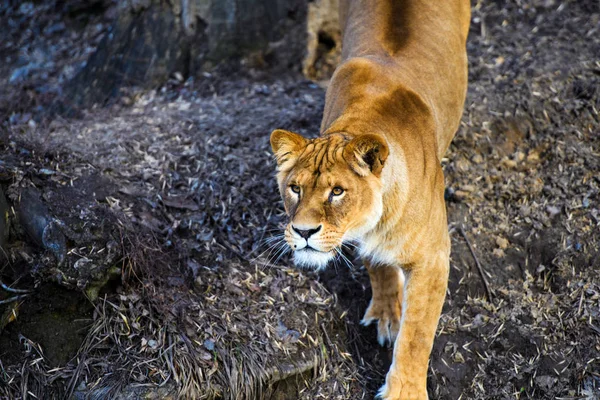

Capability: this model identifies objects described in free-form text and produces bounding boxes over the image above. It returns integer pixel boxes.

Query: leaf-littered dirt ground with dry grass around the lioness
[0,0,600,399]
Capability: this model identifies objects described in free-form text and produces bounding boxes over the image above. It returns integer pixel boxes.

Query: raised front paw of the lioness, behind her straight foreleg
[360,295,402,346]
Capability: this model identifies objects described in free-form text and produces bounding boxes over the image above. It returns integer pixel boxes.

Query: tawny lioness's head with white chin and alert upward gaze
[271,130,388,269]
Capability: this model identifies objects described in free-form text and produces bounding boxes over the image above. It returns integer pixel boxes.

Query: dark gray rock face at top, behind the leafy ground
[57,0,306,110]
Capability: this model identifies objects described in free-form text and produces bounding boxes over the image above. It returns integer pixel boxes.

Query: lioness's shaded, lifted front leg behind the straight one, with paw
[361,260,404,346]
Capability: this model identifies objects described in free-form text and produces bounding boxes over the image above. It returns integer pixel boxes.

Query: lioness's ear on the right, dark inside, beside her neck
[344,133,389,177]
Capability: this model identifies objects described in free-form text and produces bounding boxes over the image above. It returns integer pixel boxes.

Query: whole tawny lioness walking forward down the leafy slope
[271,0,470,400]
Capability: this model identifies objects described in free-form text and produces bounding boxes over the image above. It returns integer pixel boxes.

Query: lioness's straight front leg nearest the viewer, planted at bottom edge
[378,251,449,400]
